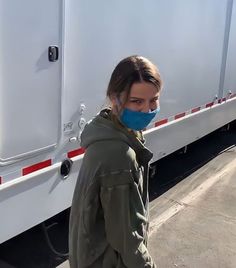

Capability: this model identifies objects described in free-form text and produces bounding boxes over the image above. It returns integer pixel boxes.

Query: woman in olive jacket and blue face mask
[69,56,162,268]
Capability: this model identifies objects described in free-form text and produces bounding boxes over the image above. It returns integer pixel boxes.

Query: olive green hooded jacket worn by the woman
[69,110,156,268]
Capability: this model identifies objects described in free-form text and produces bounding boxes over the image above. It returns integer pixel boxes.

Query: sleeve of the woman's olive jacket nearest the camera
[100,174,156,268]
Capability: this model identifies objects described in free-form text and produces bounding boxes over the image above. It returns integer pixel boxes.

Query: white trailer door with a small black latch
[0,0,62,164]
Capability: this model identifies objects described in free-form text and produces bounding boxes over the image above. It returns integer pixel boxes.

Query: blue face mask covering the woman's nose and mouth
[120,107,160,130]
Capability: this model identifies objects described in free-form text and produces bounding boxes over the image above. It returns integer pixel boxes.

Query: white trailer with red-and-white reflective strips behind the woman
[0,0,236,243]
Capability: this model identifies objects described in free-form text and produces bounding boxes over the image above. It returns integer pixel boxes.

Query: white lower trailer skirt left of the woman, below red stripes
[0,157,81,243]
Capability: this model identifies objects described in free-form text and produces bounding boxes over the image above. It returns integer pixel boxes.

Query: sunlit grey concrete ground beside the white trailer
[58,143,236,268]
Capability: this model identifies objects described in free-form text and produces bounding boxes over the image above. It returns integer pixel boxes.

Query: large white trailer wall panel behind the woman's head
[63,0,227,121]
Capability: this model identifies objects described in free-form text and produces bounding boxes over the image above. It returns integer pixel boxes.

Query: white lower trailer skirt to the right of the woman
[145,99,236,161]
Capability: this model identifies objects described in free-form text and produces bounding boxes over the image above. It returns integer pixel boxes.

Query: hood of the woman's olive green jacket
[81,109,153,161]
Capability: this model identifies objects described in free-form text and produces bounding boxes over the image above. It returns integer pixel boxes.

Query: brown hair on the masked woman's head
[107,55,162,103]
